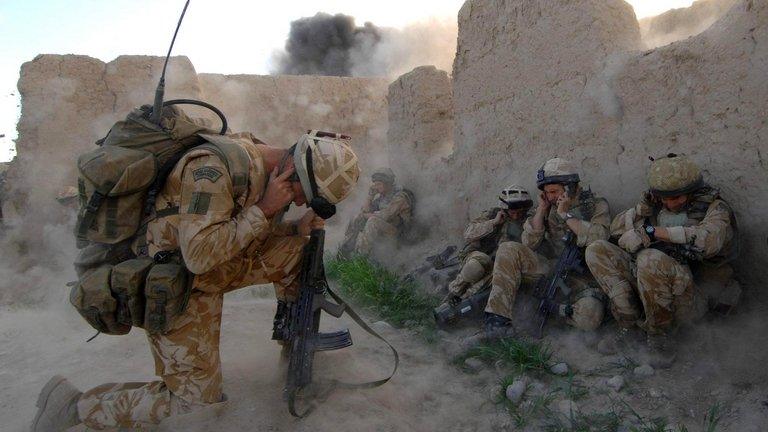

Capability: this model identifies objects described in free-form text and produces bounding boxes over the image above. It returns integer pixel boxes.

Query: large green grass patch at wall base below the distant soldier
[326,256,438,340]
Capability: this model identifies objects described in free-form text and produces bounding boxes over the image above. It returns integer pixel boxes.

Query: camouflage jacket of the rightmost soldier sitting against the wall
[611,187,738,263]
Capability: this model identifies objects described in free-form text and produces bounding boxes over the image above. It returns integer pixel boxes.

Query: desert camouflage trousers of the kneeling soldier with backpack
[77,237,306,430]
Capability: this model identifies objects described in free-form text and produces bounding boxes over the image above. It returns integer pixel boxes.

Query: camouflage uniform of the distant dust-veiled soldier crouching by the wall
[344,189,412,255]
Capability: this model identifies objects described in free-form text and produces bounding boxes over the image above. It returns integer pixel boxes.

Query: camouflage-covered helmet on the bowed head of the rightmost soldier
[648,153,704,197]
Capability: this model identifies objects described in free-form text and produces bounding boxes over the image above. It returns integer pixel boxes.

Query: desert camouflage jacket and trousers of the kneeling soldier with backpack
[78,136,305,429]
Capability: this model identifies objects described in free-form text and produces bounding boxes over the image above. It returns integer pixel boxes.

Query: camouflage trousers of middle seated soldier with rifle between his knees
[485,242,605,331]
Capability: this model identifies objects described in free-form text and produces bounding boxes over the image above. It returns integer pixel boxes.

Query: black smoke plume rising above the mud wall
[276,12,381,76]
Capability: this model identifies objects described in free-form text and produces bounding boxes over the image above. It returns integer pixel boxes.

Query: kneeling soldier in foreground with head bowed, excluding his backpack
[32,134,359,431]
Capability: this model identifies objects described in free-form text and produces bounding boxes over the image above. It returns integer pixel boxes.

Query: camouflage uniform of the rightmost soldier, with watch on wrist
[586,191,736,334]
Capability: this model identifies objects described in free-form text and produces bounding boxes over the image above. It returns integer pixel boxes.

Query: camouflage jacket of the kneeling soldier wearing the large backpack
[147,134,296,290]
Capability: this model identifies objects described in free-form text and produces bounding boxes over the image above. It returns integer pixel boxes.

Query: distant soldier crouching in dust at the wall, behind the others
[339,168,413,256]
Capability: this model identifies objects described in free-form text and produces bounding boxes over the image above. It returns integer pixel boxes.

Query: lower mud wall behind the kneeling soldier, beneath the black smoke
[13,55,387,226]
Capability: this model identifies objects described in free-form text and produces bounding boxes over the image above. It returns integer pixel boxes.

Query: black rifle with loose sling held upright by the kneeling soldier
[276,230,399,417]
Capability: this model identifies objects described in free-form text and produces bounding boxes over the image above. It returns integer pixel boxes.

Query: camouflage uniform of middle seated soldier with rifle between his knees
[485,193,611,330]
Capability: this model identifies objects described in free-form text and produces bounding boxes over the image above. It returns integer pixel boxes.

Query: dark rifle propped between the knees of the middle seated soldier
[535,231,584,338]
